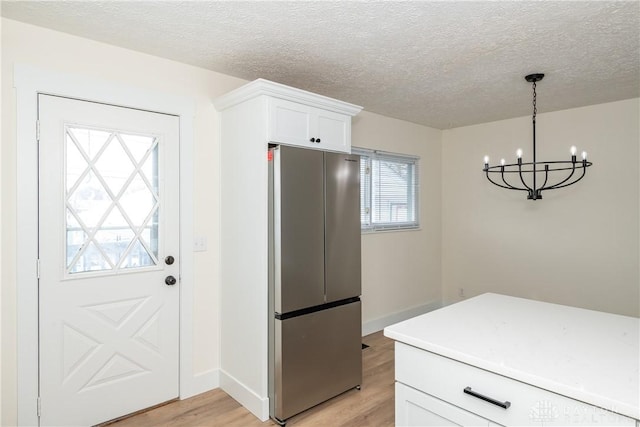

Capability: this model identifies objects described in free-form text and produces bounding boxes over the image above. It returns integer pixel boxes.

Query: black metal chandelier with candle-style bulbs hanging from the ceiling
[482,74,592,200]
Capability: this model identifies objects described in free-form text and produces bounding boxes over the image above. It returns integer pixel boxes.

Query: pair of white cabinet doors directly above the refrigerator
[268,98,351,153]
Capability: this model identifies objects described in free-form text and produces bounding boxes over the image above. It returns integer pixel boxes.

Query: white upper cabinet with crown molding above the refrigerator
[215,79,362,153]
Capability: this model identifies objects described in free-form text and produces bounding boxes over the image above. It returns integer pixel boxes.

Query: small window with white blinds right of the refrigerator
[352,148,419,231]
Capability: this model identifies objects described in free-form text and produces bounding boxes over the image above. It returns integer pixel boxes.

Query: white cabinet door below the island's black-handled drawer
[396,382,497,427]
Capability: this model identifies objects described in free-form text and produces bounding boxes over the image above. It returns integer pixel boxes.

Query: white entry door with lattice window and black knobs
[38,95,180,425]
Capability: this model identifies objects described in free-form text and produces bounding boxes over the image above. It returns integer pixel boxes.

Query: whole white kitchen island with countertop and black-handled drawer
[385,294,640,427]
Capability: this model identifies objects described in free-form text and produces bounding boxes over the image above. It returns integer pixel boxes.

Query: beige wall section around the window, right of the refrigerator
[352,111,442,334]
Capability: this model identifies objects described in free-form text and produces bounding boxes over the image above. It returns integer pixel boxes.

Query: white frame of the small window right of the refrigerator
[352,147,420,233]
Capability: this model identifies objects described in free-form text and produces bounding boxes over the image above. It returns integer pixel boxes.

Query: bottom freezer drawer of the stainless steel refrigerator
[270,300,362,420]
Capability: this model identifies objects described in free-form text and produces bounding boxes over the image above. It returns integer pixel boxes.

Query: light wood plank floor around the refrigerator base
[109,332,394,427]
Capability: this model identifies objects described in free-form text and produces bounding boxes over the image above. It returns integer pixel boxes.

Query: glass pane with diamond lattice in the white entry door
[64,125,160,274]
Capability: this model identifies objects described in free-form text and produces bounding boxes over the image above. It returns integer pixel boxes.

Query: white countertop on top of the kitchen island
[384,294,640,419]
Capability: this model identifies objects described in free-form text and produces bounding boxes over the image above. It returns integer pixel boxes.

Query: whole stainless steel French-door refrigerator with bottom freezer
[269,146,362,425]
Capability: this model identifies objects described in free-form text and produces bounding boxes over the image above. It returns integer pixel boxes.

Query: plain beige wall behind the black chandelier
[442,98,640,316]
